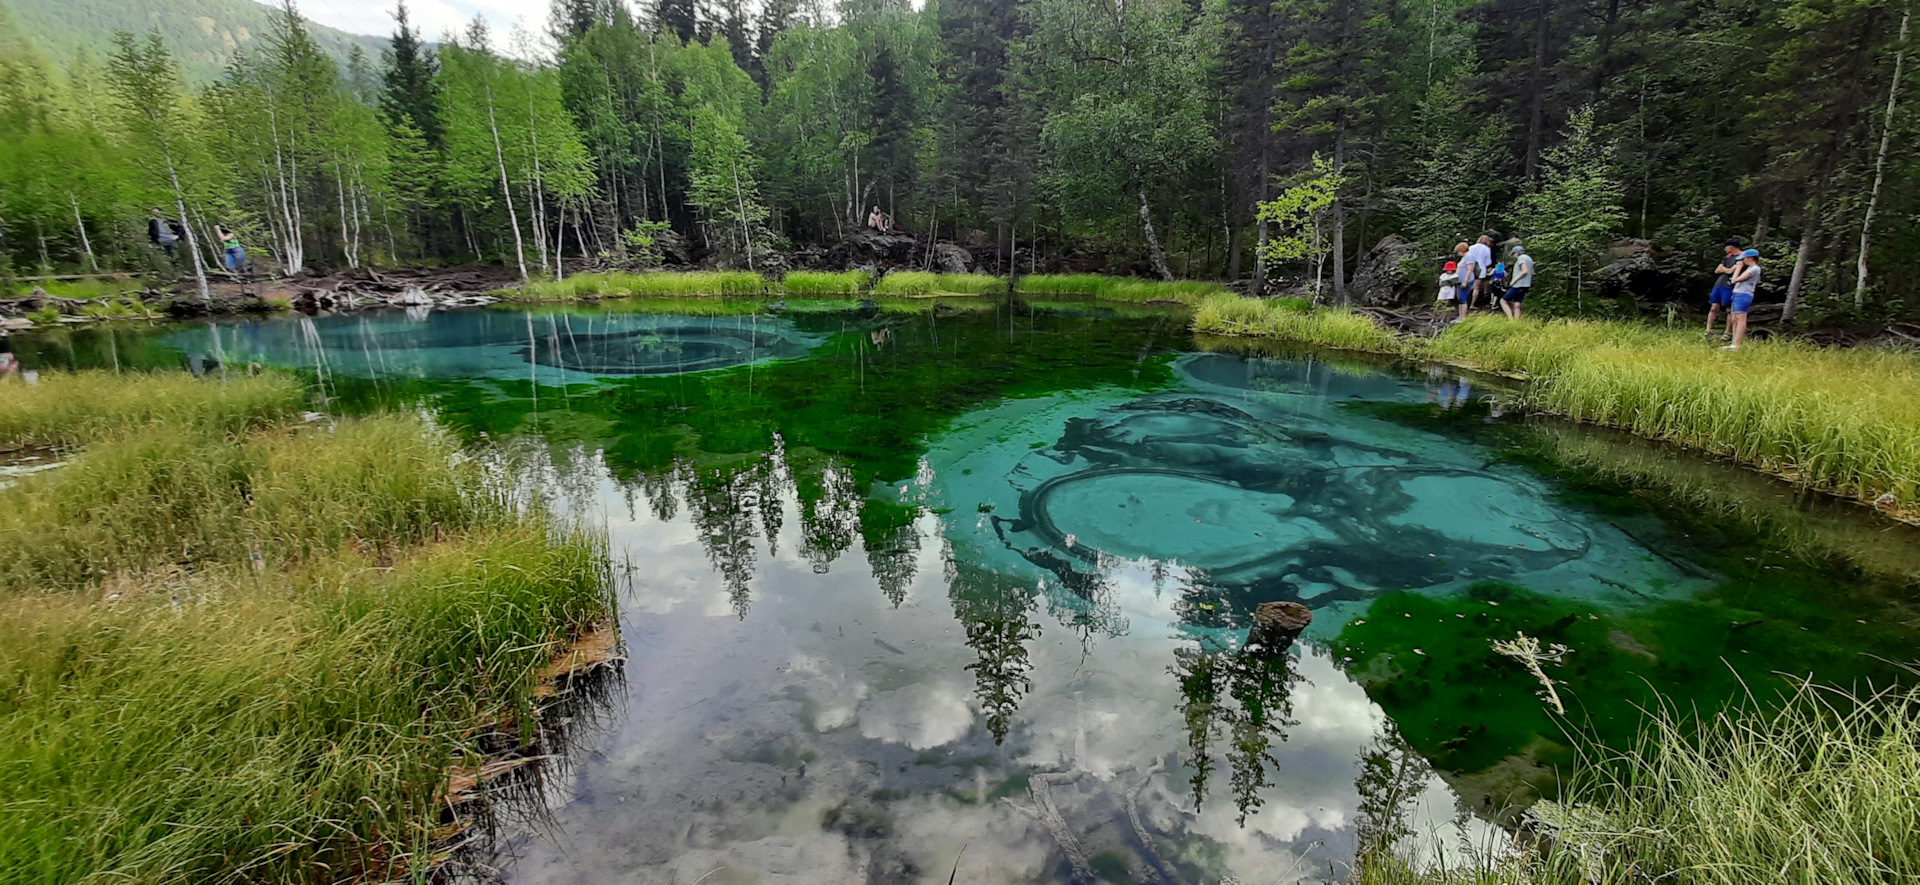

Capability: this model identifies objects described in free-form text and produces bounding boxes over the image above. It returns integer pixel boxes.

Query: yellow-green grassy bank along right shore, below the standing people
[1194,296,1920,522]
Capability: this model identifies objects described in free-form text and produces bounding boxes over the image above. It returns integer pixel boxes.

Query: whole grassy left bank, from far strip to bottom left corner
[0,372,612,883]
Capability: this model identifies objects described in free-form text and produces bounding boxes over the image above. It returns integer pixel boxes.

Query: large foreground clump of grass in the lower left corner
[0,522,611,883]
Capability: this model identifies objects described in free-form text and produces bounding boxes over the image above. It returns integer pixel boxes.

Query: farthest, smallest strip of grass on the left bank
[0,372,307,447]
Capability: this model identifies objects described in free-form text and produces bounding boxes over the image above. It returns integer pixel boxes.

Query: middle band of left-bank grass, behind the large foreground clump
[0,415,503,591]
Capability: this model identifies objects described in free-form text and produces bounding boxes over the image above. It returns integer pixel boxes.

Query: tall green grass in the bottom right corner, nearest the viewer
[1352,683,1920,885]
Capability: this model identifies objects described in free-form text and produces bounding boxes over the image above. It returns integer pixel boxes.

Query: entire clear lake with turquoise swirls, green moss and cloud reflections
[15,299,1920,885]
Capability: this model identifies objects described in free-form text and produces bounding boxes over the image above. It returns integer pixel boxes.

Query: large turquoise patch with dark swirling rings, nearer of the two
[993,394,1594,607]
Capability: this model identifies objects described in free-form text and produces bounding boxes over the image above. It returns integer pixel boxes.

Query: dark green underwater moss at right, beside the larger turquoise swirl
[1329,401,1920,785]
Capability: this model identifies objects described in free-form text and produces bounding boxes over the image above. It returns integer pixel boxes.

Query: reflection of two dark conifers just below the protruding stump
[1167,641,1302,824]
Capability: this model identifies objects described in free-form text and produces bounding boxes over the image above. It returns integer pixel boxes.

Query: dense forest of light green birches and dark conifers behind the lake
[0,0,1920,319]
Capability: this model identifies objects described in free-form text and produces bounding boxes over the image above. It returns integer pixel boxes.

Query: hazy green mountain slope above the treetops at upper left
[0,0,388,83]
